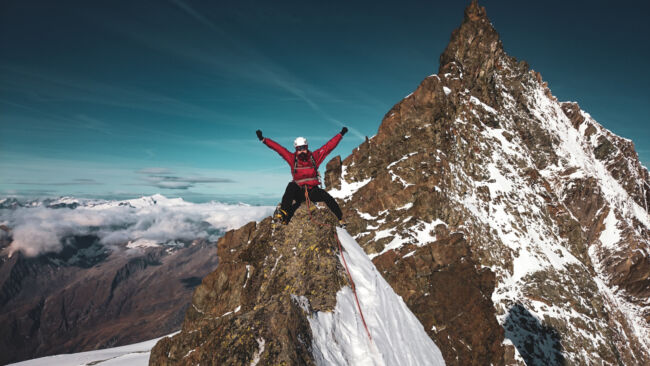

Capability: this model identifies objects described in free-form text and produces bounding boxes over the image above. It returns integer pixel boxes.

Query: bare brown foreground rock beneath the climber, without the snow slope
[149,209,347,365]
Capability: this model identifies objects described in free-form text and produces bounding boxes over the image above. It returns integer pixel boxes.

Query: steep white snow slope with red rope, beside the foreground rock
[302,228,445,366]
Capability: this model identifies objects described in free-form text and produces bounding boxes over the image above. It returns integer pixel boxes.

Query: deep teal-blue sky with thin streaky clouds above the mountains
[0,0,650,204]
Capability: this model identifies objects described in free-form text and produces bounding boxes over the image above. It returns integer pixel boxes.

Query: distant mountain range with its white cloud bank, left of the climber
[0,195,272,363]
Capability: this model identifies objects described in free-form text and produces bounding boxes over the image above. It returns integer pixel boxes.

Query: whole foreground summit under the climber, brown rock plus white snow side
[149,205,444,366]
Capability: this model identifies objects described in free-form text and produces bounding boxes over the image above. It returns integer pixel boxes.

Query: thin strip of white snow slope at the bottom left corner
[10,333,176,366]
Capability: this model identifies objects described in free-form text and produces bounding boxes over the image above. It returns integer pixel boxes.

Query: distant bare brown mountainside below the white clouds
[0,234,217,364]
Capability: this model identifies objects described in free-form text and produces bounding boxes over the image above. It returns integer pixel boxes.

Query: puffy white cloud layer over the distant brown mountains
[0,195,273,257]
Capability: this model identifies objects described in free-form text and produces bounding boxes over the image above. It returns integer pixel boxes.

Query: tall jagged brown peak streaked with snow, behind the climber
[326,1,650,365]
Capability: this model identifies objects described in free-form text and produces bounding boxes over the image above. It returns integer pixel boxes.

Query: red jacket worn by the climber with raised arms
[262,133,343,187]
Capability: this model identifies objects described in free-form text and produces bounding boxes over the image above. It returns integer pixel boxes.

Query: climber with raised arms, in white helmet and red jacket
[255,127,348,227]
